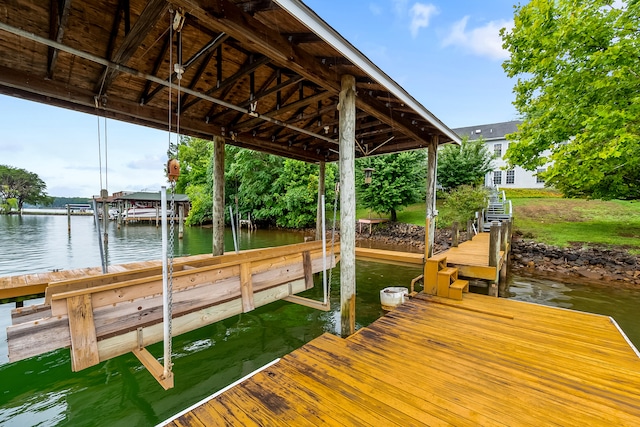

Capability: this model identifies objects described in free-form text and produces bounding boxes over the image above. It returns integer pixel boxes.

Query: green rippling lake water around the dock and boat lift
[0,215,640,427]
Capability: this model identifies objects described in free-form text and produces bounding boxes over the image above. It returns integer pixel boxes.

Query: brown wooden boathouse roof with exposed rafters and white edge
[0,0,458,162]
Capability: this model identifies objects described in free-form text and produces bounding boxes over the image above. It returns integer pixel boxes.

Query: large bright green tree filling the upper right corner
[501,0,640,198]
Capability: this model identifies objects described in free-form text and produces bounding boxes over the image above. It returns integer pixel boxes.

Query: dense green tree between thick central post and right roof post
[356,150,427,221]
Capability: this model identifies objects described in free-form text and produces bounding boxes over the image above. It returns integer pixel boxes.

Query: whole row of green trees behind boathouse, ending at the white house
[175,137,492,228]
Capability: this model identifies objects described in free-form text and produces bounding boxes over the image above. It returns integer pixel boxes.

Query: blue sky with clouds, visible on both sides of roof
[0,0,518,197]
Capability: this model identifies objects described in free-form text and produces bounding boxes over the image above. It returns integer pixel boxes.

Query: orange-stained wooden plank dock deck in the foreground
[164,294,640,427]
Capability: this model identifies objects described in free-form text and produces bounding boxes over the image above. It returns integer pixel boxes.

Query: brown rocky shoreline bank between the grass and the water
[348,223,640,287]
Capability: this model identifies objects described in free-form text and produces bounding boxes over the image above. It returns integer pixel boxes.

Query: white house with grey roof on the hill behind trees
[453,120,546,188]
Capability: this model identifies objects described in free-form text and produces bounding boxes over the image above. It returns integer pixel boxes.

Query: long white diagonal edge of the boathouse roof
[274,0,460,144]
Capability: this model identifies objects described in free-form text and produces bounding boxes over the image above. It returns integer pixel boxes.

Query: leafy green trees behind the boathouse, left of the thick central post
[176,138,337,228]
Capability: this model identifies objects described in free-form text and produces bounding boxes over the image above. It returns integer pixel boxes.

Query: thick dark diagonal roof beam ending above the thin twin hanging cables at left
[95,0,167,94]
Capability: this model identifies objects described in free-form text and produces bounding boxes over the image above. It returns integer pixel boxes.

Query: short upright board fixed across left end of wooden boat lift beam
[67,294,100,372]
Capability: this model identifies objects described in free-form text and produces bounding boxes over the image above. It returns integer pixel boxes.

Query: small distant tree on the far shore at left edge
[0,165,52,211]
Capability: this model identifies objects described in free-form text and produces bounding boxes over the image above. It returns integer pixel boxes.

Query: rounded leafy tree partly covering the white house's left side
[438,136,494,190]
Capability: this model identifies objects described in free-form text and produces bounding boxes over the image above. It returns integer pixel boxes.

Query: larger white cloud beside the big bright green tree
[442,16,513,59]
